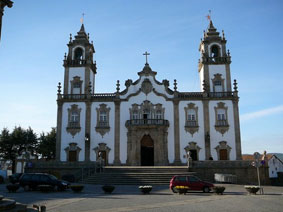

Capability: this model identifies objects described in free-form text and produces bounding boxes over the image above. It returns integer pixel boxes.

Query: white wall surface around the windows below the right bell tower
[209,100,236,160]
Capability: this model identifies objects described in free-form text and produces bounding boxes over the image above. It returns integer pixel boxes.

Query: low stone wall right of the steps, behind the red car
[190,161,270,185]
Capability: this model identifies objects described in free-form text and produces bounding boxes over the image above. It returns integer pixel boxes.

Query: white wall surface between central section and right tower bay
[179,101,205,163]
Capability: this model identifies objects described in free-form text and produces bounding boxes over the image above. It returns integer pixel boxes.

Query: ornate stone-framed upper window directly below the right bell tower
[214,102,229,136]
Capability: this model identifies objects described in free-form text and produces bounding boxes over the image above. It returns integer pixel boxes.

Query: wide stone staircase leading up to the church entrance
[81,166,194,186]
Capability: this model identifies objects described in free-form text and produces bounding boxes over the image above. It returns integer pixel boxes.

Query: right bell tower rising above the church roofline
[198,20,232,92]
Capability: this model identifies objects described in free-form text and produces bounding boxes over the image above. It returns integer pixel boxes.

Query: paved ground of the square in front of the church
[0,184,283,212]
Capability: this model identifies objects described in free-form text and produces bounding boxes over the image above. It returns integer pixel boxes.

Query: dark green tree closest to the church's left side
[37,128,56,160]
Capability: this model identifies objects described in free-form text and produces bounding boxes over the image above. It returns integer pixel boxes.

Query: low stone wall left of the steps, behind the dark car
[25,161,103,181]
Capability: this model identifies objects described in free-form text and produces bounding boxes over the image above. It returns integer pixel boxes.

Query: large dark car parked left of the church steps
[19,173,70,191]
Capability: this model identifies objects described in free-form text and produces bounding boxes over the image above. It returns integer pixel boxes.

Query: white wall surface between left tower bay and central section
[90,102,115,164]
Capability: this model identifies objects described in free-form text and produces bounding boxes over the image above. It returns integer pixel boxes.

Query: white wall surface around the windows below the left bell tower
[60,102,86,161]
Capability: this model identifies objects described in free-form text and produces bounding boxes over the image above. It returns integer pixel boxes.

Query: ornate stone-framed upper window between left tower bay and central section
[95,104,110,137]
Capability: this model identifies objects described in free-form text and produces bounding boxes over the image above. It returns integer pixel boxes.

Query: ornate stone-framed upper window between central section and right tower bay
[184,103,199,136]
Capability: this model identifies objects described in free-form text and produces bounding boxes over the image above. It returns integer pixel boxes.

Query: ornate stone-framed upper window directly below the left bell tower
[66,104,82,137]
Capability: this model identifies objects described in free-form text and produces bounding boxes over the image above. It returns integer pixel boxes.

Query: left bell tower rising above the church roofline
[63,24,96,95]
